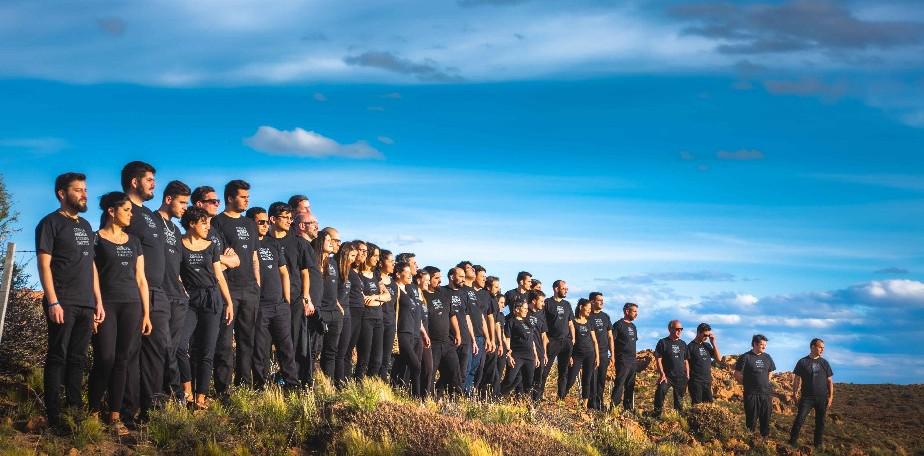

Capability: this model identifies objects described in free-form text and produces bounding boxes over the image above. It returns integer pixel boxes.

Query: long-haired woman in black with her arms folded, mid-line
[353,244,391,380]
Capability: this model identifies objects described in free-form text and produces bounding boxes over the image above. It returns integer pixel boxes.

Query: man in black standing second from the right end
[735,334,776,437]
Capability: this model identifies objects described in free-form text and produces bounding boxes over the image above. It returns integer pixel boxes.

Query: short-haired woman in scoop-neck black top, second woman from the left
[177,206,234,409]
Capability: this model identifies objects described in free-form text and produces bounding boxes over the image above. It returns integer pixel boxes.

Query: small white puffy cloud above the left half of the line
[244,125,383,159]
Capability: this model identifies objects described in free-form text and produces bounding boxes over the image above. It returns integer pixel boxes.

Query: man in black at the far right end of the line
[789,338,834,449]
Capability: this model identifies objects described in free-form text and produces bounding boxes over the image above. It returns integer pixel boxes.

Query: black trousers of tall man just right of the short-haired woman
[215,284,260,394]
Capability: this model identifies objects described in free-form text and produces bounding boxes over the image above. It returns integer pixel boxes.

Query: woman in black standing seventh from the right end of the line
[559,298,600,407]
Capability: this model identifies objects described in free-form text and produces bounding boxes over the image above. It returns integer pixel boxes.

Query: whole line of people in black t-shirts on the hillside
[36,161,833,443]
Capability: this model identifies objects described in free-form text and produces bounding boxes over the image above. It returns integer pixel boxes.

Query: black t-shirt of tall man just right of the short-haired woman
[212,213,260,290]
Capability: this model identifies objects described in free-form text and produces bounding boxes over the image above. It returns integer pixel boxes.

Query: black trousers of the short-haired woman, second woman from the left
[177,288,228,394]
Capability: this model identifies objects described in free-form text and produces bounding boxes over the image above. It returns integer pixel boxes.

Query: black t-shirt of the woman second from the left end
[94,233,142,304]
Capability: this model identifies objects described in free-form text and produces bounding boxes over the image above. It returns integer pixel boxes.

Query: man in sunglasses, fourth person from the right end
[654,320,690,417]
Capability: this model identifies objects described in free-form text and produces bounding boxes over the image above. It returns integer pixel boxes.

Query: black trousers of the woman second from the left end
[87,301,142,412]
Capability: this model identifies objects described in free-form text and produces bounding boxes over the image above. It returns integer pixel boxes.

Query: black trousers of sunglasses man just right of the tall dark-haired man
[253,300,298,388]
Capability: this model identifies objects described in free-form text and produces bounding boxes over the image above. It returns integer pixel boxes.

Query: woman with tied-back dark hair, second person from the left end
[88,192,152,436]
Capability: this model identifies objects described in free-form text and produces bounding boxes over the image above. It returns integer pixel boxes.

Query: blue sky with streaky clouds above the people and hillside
[0,0,924,383]
